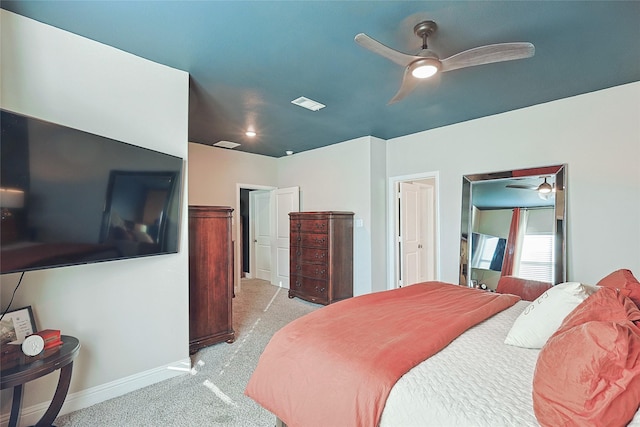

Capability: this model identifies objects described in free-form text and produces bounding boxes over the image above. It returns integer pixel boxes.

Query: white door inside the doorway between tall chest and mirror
[398,182,424,286]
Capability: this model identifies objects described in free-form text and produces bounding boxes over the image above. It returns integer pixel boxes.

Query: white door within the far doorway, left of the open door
[249,191,271,281]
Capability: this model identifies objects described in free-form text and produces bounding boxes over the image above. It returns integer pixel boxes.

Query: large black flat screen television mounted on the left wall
[0,110,183,274]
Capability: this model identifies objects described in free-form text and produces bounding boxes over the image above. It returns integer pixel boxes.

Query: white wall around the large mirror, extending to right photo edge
[387,82,640,283]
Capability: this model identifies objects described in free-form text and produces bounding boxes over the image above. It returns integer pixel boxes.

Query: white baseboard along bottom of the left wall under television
[0,358,191,427]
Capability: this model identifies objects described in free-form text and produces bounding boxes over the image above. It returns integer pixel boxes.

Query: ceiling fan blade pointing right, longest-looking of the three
[441,42,535,72]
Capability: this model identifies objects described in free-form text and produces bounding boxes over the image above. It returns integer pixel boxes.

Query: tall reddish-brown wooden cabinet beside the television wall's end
[189,206,235,354]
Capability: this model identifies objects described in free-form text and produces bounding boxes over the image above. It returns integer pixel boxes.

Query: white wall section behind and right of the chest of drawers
[278,137,386,295]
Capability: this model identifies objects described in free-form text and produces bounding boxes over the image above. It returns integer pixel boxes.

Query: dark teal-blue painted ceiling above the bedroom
[1,0,640,157]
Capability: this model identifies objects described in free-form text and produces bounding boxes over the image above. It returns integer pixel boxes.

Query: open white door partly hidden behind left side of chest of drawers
[271,187,300,288]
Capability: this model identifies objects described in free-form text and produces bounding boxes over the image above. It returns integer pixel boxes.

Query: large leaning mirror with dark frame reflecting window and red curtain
[459,165,567,290]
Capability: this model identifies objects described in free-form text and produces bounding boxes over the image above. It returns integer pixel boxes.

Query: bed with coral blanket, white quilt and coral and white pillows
[245,270,640,427]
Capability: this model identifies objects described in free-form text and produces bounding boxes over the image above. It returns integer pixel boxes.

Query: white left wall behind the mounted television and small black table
[0,10,189,424]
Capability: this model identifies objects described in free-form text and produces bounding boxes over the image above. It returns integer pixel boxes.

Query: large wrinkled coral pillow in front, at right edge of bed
[533,288,640,427]
